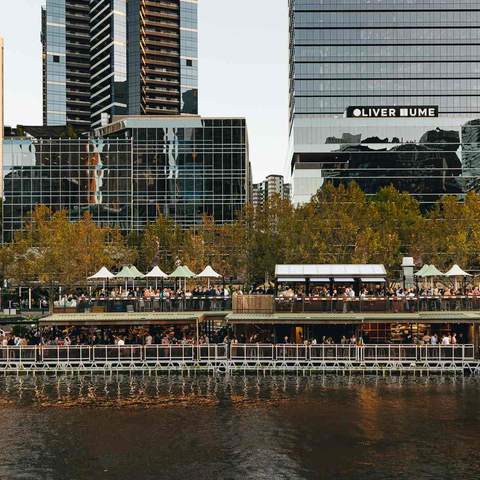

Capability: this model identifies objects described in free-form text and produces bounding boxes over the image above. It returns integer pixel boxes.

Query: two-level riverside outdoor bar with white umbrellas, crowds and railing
[0,259,480,373]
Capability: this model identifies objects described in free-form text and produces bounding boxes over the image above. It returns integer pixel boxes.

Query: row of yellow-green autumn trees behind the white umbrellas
[0,183,480,285]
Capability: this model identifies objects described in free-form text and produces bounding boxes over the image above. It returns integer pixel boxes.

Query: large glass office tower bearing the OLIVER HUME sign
[289,0,480,207]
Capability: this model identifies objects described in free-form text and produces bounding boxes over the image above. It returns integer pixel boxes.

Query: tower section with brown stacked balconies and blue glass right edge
[128,0,198,115]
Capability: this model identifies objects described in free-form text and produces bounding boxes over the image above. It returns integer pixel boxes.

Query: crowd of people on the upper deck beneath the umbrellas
[9,284,480,312]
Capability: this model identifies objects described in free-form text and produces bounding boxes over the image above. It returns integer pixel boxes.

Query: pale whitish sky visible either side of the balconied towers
[0,0,289,181]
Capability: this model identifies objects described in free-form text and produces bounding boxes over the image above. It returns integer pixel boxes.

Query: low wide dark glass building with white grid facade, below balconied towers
[3,117,251,240]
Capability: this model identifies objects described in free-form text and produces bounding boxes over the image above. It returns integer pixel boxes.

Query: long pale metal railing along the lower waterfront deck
[0,344,475,370]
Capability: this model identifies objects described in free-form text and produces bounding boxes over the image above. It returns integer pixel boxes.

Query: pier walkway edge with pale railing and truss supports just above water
[0,344,480,374]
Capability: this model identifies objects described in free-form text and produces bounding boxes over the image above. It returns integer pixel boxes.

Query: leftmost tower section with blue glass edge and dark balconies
[42,0,90,129]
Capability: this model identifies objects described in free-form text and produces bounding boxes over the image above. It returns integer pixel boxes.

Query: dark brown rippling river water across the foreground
[0,375,480,480]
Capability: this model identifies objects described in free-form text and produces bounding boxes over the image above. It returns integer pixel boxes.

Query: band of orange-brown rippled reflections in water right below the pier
[0,374,480,408]
